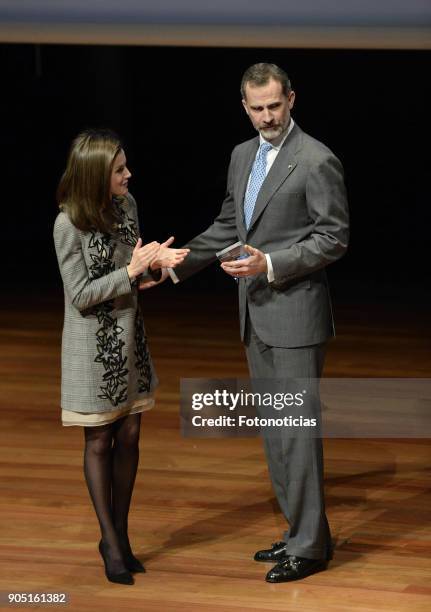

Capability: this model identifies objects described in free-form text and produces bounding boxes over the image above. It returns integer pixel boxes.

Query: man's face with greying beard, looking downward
[242,79,295,142]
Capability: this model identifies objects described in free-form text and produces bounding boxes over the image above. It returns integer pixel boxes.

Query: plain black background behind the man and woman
[0,45,430,308]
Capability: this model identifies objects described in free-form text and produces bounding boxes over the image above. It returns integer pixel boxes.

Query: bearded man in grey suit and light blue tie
[167,64,348,582]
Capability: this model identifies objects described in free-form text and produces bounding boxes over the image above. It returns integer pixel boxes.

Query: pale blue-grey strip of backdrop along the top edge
[0,0,431,49]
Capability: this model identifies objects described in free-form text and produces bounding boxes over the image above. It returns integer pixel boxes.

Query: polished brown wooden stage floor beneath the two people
[0,289,431,612]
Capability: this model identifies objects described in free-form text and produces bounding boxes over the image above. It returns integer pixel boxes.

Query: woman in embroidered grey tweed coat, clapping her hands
[54,130,188,584]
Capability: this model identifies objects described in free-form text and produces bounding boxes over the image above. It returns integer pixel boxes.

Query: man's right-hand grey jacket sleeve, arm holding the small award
[270,153,349,282]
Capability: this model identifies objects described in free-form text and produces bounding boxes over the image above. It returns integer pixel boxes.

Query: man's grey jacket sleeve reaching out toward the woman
[174,155,238,280]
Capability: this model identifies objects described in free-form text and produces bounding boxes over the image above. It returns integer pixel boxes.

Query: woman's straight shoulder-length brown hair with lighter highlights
[57,129,123,234]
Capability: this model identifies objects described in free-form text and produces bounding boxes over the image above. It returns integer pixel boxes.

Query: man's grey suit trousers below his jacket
[244,314,331,559]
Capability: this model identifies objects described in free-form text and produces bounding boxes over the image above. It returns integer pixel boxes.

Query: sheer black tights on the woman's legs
[84,414,141,573]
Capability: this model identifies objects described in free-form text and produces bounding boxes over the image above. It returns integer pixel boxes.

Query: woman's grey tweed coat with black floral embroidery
[54,194,157,413]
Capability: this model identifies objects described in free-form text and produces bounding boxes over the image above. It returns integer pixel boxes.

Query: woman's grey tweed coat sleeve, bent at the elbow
[54,212,132,311]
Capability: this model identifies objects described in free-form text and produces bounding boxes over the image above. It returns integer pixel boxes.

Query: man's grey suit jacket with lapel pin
[175,124,348,347]
